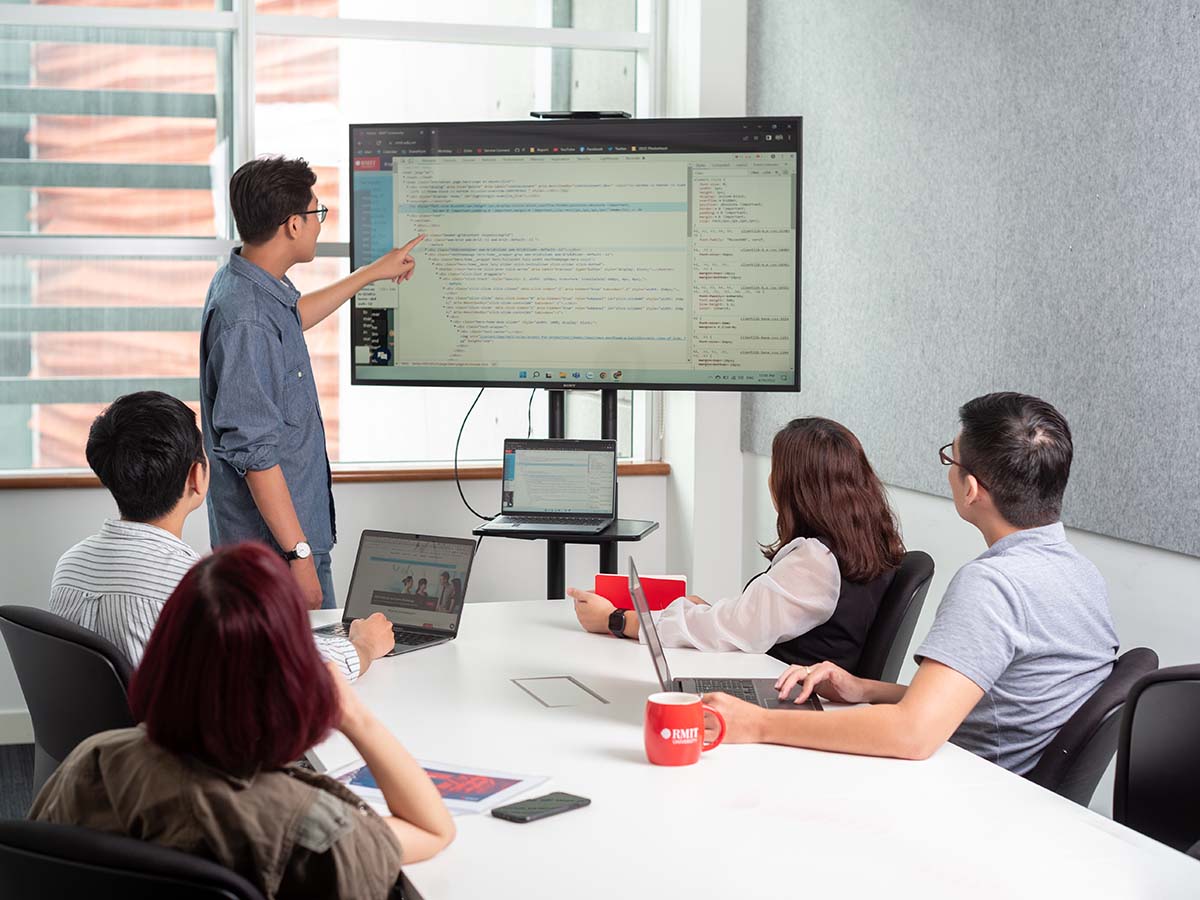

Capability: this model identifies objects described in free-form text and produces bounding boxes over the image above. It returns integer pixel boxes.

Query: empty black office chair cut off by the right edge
[1112,665,1200,851]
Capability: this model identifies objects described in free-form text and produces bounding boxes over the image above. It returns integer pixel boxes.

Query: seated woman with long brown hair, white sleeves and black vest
[570,418,904,671]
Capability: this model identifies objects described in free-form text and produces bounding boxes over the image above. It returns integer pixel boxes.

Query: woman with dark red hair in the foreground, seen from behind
[30,544,455,899]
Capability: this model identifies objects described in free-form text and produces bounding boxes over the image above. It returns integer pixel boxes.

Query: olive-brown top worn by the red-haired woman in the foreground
[29,727,401,900]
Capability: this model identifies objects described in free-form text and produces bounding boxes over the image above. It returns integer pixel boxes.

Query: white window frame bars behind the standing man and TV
[0,0,667,480]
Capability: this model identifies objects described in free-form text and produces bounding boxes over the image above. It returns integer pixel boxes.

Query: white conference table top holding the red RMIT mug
[313,600,1200,900]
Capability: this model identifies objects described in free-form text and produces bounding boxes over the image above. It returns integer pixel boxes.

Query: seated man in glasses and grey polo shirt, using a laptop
[706,392,1118,774]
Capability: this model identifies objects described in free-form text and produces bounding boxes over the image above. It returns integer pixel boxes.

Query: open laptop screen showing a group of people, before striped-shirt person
[346,532,475,632]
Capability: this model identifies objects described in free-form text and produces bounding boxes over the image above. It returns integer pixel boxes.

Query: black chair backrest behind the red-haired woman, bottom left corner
[0,821,263,900]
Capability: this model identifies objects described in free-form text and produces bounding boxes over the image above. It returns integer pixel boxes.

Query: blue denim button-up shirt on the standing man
[200,250,337,553]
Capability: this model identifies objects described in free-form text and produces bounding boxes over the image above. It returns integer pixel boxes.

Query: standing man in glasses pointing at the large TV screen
[200,157,425,608]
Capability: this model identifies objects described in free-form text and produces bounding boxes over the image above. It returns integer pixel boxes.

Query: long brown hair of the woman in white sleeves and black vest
[762,418,904,583]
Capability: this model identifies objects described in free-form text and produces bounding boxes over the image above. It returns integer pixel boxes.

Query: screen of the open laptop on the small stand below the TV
[500,439,617,516]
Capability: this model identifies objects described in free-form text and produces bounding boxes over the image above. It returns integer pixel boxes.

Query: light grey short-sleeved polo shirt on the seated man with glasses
[916,523,1120,774]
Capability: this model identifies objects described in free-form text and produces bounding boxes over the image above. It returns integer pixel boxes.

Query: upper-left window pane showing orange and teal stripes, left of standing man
[0,26,232,236]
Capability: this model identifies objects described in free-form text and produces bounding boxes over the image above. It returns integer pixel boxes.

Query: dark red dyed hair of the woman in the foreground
[130,544,340,775]
